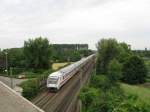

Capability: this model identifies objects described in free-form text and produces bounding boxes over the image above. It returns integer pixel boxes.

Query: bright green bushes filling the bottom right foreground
[80,72,150,112]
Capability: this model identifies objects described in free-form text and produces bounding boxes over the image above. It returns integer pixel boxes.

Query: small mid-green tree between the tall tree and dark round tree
[107,59,122,84]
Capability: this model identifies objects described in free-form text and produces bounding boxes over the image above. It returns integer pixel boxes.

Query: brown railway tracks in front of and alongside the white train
[32,58,92,112]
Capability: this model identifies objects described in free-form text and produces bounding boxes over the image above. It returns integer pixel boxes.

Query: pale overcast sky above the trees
[0,0,150,49]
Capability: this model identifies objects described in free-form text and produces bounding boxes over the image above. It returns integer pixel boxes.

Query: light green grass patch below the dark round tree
[121,84,150,103]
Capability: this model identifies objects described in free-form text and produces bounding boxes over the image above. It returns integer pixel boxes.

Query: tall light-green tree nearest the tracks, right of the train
[96,38,119,74]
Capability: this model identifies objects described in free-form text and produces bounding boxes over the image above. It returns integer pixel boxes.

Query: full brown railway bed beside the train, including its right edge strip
[32,57,95,112]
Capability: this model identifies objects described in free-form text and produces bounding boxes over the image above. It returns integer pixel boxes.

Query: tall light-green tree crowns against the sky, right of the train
[96,38,132,74]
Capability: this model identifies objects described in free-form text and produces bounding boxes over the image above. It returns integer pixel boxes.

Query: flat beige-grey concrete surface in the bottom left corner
[0,81,44,112]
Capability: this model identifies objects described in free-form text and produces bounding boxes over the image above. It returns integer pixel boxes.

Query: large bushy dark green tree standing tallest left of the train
[24,37,50,69]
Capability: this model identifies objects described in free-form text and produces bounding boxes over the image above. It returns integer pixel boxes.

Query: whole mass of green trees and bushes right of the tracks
[80,39,150,112]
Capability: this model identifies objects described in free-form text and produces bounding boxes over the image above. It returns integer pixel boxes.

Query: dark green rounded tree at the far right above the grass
[123,56,147,84]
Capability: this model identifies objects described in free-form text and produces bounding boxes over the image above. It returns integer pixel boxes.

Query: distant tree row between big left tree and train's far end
[50,44,93,62]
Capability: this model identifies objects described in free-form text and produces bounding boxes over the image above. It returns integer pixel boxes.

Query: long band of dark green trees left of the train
[0,37,92,76]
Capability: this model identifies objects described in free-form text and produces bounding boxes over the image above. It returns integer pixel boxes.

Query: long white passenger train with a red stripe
[46,54,95,91]
